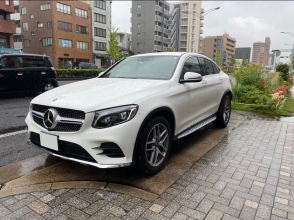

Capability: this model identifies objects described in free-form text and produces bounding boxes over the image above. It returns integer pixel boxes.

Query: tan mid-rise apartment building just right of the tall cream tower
[203,33,236,66]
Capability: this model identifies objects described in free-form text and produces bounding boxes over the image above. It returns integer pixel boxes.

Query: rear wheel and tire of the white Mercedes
[213,95,231,128]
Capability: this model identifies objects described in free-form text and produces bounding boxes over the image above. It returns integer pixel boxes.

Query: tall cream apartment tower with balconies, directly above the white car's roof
[173,1,204,53]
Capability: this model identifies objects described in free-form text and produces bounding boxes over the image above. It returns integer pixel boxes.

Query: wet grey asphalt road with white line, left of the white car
[0,81,73,167]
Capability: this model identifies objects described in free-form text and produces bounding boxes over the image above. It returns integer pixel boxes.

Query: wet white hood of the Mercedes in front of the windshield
[32,78,171,112]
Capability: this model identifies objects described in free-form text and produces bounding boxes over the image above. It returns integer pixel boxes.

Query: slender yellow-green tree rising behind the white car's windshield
[105,27,123,62]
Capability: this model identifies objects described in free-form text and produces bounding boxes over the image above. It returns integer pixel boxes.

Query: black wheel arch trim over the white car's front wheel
[132,107,176,164]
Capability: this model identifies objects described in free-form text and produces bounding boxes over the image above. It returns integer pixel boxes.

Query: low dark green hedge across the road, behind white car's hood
[56,68,105,78]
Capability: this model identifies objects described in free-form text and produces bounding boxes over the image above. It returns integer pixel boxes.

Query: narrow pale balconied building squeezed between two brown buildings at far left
[10,0,22,49]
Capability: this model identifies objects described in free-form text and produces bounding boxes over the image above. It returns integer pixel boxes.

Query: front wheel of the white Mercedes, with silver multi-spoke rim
[137,116,172,175]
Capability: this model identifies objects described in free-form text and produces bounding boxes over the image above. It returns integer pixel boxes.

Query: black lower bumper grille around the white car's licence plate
[31,132,97,162]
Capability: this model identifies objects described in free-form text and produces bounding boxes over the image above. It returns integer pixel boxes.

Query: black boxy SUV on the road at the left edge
[0,53,58,93]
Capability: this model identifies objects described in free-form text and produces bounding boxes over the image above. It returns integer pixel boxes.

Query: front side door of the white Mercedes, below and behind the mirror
[172,56,210,133]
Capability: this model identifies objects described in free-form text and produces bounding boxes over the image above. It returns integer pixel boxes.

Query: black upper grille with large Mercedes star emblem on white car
[32,104,85,132]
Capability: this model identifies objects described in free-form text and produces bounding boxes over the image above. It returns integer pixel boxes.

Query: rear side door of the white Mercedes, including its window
[199,57,222,115]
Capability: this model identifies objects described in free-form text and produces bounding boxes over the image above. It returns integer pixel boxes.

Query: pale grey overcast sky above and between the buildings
[112,1,294,62]
